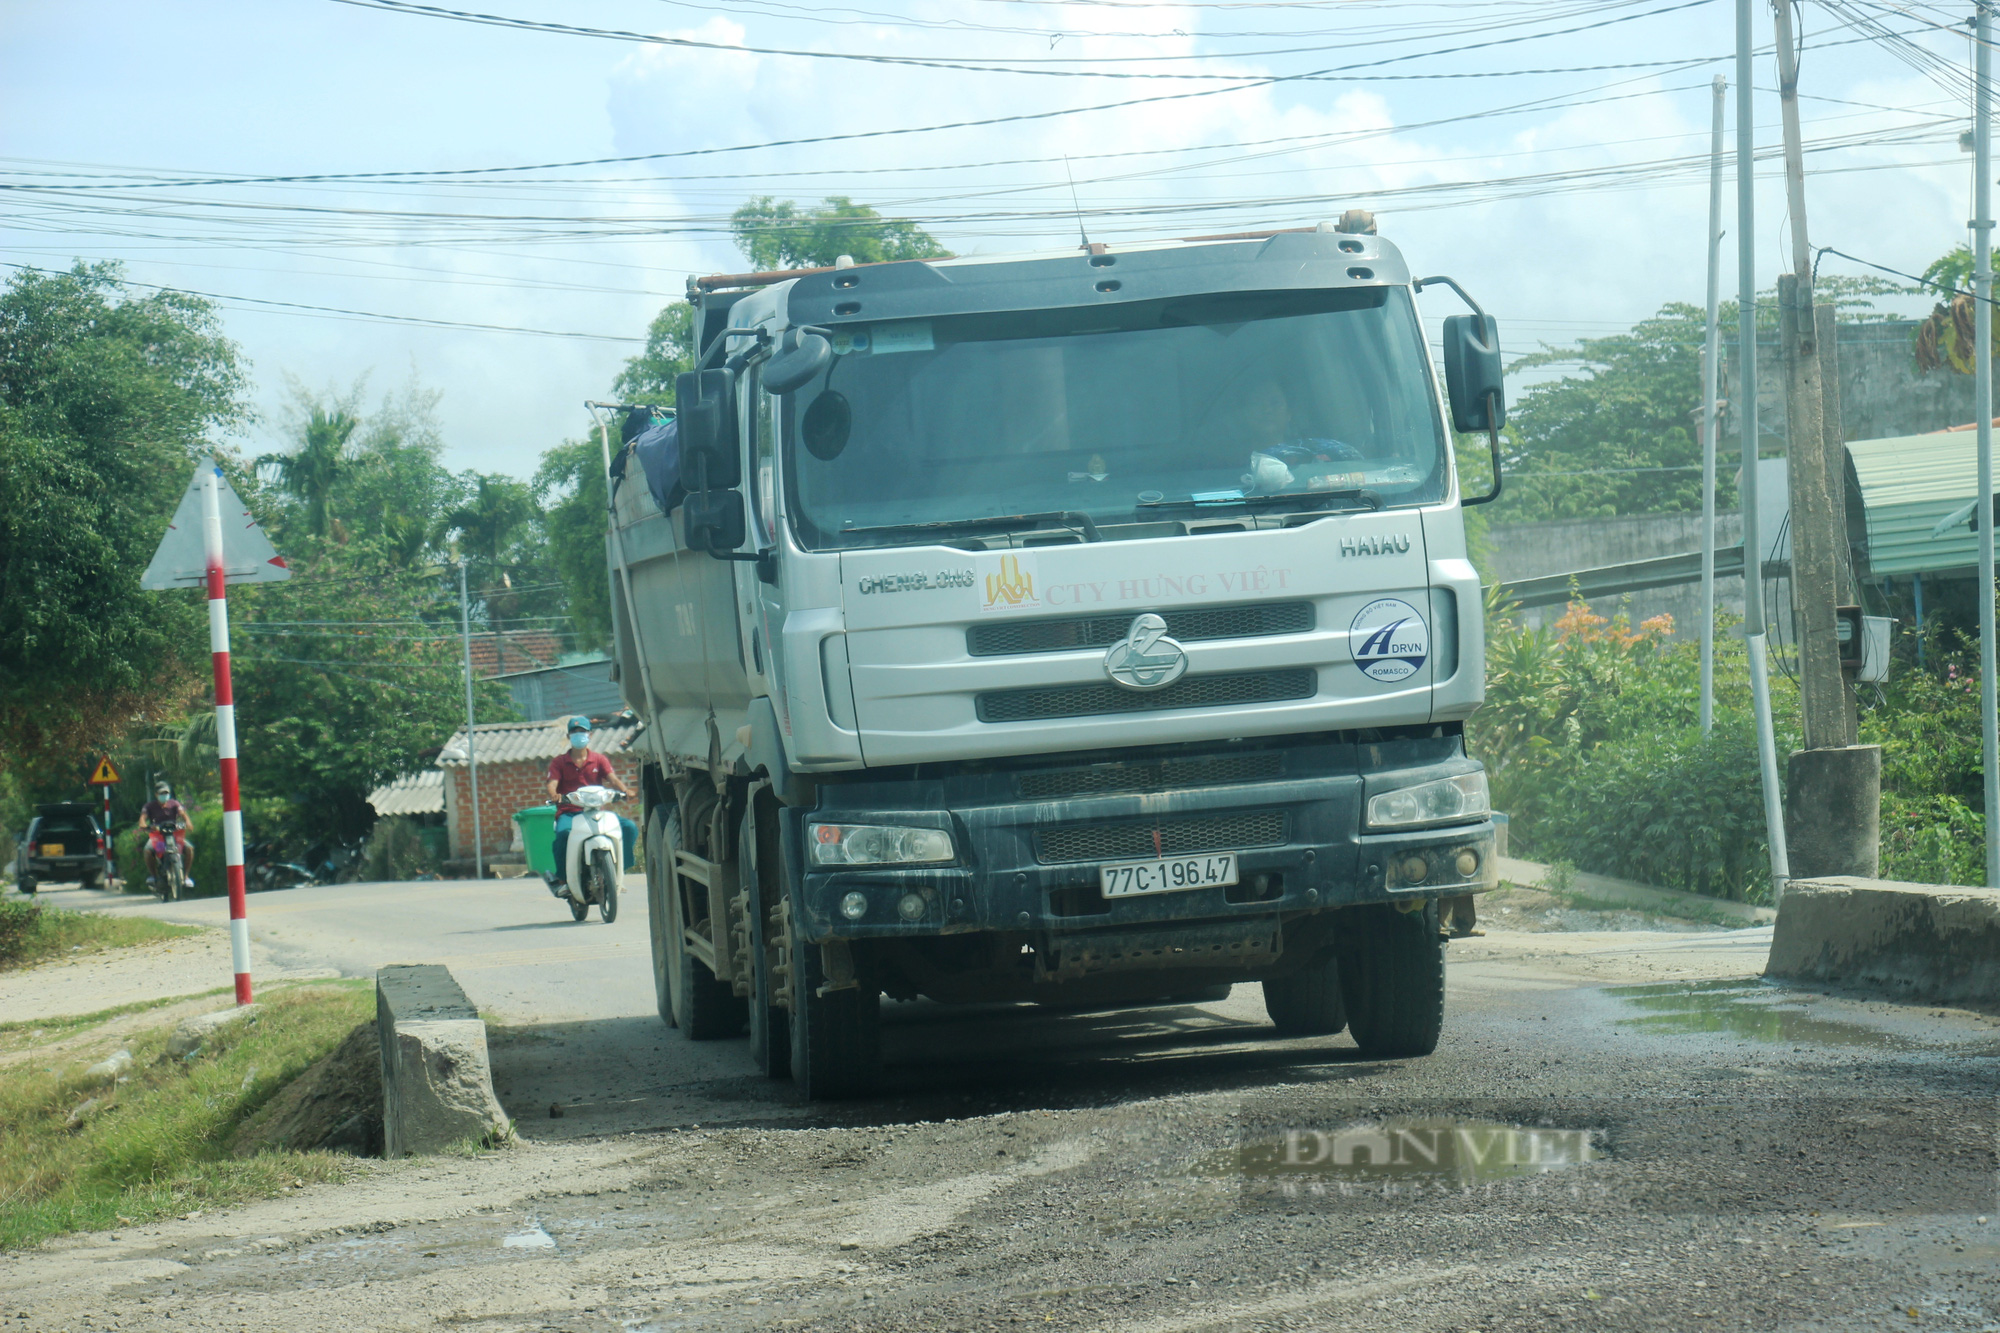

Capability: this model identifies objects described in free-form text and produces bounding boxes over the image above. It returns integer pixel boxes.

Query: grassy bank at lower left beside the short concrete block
[0,983,374,1251]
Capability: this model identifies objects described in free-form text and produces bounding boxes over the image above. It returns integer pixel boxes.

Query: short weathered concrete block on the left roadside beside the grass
[376,963,508,1157]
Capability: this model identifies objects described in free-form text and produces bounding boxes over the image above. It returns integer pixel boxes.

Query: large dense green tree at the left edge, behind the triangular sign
[0,264,244,785]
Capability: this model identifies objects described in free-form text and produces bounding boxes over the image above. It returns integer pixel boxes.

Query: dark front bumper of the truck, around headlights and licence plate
[782,735,1496,941]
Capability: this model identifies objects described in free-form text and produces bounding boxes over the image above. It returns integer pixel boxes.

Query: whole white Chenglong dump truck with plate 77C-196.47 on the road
[604,212,1506,1097]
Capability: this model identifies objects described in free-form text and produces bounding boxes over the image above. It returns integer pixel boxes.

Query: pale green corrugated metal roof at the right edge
[1848,430,1980,576]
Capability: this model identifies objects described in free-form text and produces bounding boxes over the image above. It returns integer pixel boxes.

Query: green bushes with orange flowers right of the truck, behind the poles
[1466,600,1984,903]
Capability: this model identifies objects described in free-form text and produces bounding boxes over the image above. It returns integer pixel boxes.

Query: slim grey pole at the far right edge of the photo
[1972,0,2000,889]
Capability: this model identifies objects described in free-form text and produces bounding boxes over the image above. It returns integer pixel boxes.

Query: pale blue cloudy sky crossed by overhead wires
[0,0,1970,474]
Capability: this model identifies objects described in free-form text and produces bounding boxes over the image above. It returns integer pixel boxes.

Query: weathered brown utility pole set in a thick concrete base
[1772,0,1882,879]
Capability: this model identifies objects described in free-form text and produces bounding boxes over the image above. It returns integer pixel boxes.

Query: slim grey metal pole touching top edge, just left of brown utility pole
[1736,0,1792,905]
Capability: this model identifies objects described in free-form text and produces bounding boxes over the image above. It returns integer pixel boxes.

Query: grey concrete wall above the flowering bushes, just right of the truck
[1488,514,1744,638]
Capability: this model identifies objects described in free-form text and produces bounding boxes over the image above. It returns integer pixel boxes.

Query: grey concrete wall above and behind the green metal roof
[1720,320,2000,444]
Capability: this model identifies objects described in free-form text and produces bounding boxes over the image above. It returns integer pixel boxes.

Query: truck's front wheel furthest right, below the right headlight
[1340,901,1444,1059]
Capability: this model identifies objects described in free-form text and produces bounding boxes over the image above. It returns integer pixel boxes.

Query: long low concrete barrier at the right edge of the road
[1764,877,2000,1005]
